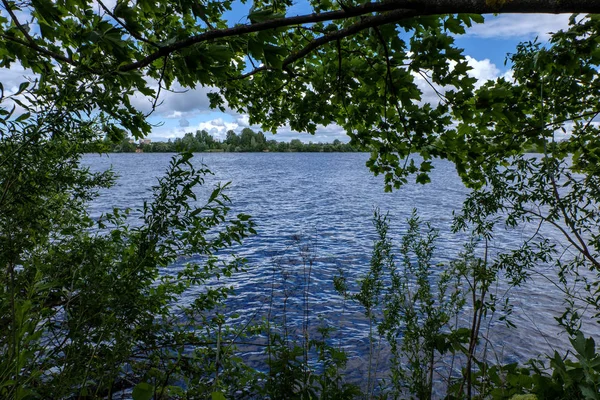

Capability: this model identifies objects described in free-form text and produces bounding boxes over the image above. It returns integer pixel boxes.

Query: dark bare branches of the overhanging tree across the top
[1,0,600,77]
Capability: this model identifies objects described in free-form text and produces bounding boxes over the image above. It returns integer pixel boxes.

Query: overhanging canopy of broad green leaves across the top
[0,0,600,188]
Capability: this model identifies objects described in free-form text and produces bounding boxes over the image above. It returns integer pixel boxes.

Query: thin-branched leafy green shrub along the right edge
[446,16,600,397]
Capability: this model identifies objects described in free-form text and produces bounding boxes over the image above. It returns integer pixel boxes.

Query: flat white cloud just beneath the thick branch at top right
[467,14,570,40]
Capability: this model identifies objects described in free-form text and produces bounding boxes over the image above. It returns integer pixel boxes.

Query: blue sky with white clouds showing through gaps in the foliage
[0,0,569,142]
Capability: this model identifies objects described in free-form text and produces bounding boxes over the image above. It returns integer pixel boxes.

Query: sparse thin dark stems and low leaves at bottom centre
[257,235,361,400]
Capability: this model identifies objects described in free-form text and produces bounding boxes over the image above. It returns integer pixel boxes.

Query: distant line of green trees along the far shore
[90,128,362,153]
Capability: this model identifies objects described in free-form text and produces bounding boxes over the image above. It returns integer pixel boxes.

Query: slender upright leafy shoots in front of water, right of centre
[336,210,480,399]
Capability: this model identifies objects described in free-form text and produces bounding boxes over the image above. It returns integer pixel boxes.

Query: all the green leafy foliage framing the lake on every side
[0,0,600,400]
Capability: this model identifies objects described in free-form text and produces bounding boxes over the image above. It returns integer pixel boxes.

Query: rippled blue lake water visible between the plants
[83,153,588,376]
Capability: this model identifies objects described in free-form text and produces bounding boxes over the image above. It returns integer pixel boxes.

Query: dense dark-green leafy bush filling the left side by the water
[0,77,254,399]
